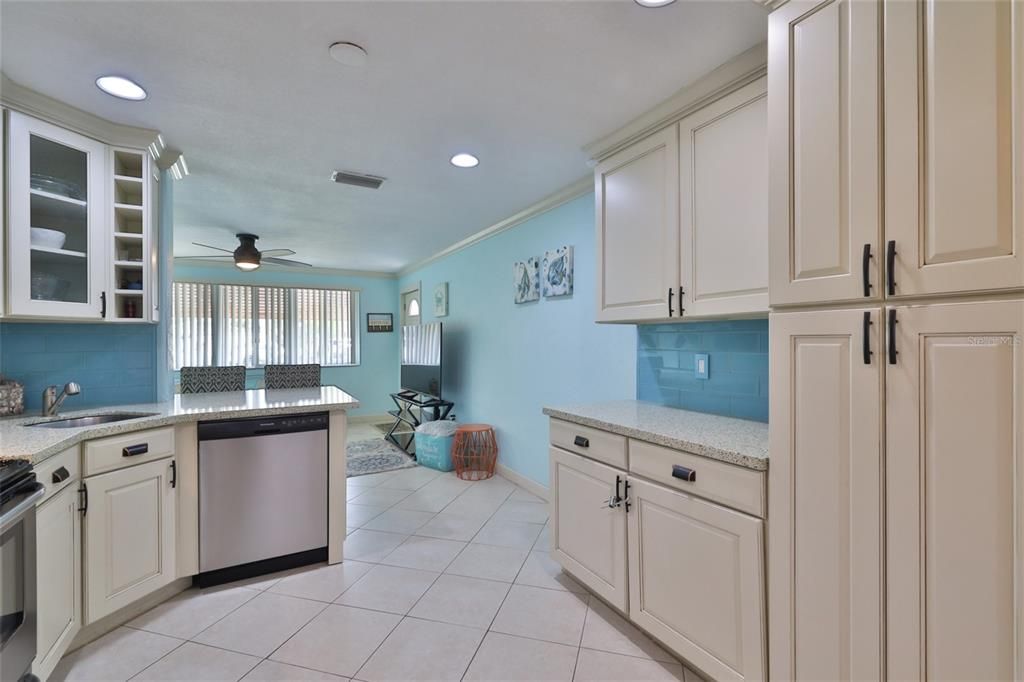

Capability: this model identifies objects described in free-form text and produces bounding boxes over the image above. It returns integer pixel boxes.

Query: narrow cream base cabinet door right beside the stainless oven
[33,481,82,680]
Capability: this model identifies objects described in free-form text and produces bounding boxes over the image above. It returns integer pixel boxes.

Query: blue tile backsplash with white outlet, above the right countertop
[637,319,768,422]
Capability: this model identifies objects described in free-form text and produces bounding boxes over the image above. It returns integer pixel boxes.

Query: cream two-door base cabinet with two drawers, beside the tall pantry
[550,422,768,680]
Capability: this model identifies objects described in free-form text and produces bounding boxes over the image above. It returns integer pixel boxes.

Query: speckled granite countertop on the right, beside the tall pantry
[544,400,768,471]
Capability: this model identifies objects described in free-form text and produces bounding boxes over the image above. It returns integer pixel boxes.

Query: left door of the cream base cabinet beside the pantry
[550,447,629,611]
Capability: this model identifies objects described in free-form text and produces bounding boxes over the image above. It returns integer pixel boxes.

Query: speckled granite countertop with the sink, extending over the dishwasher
[0,386,359,463]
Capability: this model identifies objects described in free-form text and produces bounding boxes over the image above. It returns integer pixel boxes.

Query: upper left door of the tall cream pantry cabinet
[768,0,882,305]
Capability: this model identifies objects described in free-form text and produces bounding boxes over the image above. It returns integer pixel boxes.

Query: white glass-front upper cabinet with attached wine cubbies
[4,112,156,322]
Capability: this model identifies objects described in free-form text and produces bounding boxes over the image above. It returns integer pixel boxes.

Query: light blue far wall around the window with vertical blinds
[174,261,398,415]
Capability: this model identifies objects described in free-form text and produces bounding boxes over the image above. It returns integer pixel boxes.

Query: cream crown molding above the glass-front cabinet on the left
[0,73,160,150]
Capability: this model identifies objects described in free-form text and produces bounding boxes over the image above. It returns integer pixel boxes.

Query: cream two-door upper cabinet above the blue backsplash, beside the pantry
[595,79,768,323]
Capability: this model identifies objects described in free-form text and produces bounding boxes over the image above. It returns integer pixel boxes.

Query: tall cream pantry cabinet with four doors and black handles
[768,0,1024,680]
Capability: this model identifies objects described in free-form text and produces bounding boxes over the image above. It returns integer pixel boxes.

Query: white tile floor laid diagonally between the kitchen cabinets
[51,431,697,682]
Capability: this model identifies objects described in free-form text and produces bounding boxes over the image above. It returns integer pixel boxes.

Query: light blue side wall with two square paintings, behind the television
[400,195,636,485]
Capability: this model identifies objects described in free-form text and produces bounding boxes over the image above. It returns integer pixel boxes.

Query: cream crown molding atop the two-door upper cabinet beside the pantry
[583,42,768,161]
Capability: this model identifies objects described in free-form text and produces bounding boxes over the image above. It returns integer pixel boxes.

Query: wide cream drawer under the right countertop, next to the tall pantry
[630,438,766,518]
